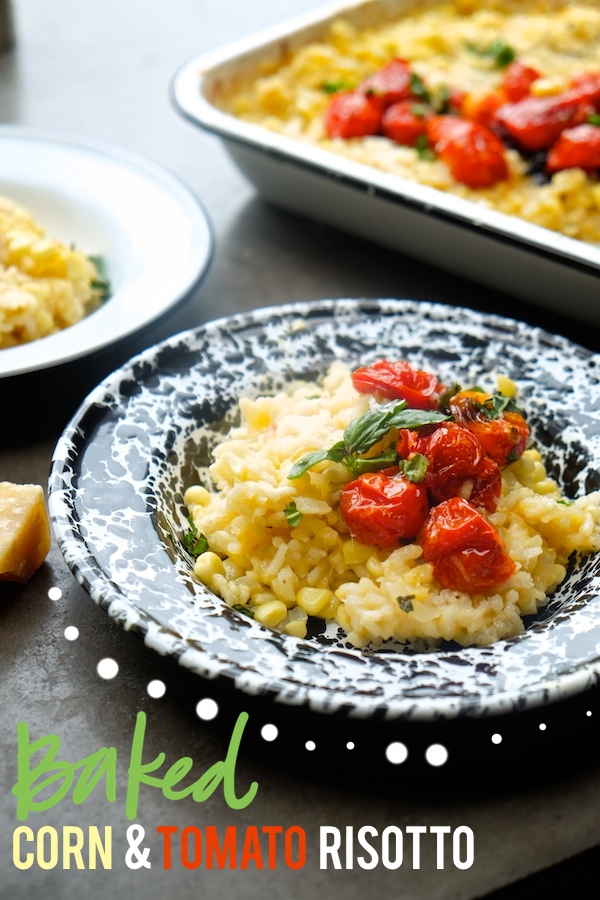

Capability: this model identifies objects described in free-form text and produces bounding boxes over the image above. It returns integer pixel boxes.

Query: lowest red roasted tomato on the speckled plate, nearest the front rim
[422,497,516,594]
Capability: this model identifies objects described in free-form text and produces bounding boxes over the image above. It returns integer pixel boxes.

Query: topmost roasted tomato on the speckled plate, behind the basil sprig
[352,359,446,409]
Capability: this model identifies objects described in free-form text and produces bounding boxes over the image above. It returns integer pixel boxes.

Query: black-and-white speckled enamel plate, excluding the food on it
[49,300,600,720]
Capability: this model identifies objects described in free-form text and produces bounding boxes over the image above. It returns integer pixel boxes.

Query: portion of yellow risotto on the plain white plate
[0,196,109,350]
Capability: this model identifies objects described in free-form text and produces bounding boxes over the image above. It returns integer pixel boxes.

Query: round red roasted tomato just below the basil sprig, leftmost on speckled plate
[340,468,429,547]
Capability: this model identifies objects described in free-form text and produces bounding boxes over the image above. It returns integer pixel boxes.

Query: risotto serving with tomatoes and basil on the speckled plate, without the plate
[184,359,600,647]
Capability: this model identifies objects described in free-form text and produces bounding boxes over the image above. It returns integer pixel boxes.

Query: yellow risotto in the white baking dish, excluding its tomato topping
[227,0,600,243]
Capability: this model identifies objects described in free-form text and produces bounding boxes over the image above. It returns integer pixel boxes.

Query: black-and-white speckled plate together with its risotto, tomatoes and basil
[50,300,600,719]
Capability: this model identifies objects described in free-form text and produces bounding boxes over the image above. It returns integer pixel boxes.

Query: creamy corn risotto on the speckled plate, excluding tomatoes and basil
[185,363,600,647]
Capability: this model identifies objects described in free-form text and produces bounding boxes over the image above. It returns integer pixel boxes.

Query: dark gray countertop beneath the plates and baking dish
[0,0,600,900]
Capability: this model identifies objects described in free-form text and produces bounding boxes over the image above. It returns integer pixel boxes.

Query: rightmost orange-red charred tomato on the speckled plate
[449,391,529,467]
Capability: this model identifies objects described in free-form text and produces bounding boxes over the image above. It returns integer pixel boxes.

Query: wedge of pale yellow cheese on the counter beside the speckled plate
[0,481,50,583]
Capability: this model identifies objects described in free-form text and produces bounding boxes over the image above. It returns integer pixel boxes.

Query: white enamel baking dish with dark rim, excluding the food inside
[173,0,600,325]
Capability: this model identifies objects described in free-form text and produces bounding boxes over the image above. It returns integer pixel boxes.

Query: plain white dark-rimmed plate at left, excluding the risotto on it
[0,126,213,377]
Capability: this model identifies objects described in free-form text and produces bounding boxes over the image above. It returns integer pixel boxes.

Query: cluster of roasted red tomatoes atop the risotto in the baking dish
[325,59,600,188]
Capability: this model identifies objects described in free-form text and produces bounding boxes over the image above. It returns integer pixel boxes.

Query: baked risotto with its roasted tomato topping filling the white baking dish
[227,0,600,243]
